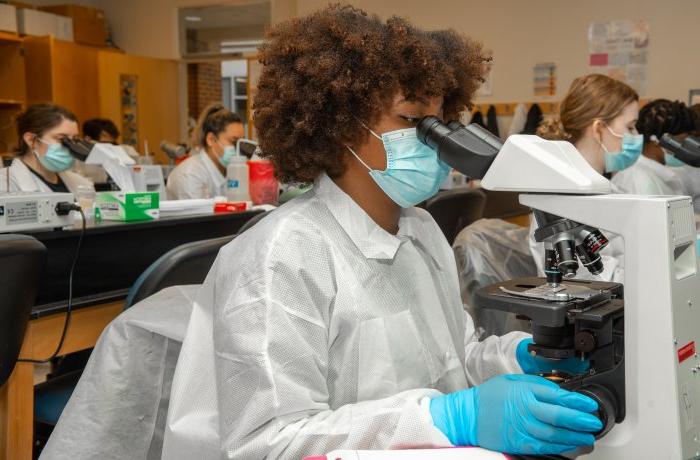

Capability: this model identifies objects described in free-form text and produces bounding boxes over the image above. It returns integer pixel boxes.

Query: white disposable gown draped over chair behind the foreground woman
[41,285,199,460]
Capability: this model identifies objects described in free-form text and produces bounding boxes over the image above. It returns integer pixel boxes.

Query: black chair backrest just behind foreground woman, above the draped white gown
[124,235,235,309]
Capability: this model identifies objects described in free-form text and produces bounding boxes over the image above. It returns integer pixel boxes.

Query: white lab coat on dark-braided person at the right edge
[610,155,685,195]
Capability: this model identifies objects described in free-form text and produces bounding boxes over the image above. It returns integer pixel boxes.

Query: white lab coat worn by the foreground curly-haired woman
[163,175,528,459]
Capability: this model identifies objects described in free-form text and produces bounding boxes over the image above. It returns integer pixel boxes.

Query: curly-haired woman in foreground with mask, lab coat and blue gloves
[153,5,602,459]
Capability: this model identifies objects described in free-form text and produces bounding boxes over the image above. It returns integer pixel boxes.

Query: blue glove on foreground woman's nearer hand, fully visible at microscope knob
[430,374,603,454]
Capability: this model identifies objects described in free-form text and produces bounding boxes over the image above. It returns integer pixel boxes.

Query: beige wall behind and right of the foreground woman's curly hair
[297,0,700,102]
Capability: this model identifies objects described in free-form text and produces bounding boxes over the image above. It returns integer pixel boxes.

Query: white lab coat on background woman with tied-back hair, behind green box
[167,150,226,200]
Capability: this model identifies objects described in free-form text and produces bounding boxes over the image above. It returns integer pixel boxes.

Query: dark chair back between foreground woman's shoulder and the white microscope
[425,188,486,245]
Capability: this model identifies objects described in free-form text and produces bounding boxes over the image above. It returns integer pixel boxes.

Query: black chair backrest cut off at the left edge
[0,235,46,387]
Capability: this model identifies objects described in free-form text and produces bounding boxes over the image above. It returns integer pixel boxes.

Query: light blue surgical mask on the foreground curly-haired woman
[348,124,450,208]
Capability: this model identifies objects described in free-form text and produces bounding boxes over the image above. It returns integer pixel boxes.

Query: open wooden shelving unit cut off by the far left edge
[0,32,27,156]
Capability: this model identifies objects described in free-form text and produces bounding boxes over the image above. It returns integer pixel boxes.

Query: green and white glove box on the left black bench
[95,192,160,222]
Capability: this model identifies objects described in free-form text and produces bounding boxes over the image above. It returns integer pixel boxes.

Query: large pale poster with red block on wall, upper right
[588,19,649,95]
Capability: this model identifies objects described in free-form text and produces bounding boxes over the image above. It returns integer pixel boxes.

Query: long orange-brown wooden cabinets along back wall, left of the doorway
[24,37,181,163]
